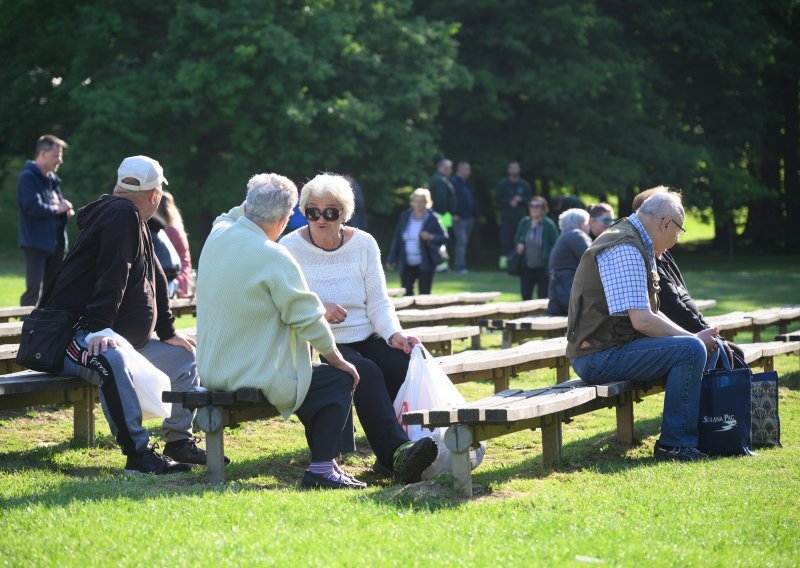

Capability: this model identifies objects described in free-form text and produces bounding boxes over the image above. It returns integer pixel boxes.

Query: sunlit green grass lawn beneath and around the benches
[0,251,800,566]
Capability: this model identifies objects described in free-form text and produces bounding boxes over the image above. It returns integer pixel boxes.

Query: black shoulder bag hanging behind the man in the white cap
[17,308,79,374]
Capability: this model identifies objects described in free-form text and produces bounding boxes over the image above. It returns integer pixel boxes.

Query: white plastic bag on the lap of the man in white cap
[86,328,172,420]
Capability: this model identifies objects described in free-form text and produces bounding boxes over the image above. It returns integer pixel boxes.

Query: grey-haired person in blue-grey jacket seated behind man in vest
[547,209,592,316]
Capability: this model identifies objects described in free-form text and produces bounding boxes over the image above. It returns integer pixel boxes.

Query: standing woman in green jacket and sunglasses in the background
[514,195,558,300]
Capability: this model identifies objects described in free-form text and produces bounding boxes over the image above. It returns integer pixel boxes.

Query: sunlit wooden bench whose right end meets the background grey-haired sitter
[397,300,547,326]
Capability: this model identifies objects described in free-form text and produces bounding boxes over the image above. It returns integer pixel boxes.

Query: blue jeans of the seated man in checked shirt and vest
[572,336,706,448]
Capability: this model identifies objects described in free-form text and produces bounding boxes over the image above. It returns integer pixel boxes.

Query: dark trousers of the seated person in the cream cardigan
[295,365,353,462]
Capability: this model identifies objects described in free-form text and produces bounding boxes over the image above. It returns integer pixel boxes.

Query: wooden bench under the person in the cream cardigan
[161,388,280,483]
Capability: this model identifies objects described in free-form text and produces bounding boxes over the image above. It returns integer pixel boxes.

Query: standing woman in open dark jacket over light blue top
[386,188,447,296]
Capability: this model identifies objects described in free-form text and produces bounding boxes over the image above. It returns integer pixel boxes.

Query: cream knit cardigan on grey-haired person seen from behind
[197,206,334,418]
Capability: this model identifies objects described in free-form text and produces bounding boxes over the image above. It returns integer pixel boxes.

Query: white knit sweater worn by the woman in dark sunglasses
[280,229,402,343]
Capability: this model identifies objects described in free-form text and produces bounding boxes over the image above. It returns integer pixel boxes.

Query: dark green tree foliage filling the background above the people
[0,0,800,248]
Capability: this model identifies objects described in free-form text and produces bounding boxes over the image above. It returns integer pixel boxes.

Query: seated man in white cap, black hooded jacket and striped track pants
[42,156,212,474]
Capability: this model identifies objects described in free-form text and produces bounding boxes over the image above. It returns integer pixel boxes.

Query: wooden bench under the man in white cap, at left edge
[0,371,98,447]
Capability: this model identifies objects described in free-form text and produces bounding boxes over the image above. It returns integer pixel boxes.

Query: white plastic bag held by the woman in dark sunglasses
[394,343,486,479]
